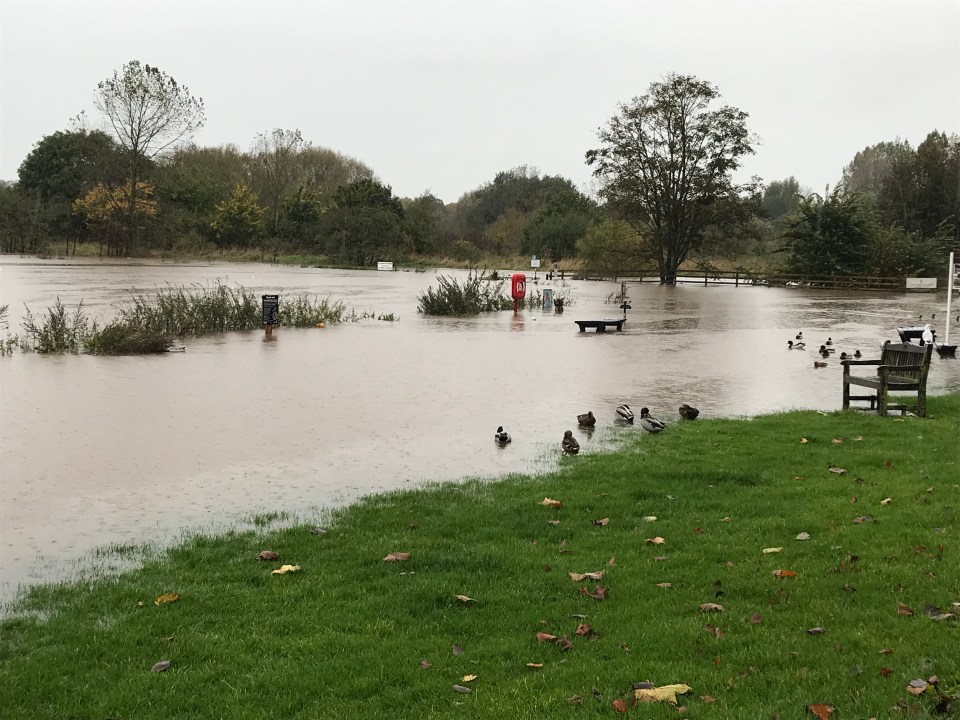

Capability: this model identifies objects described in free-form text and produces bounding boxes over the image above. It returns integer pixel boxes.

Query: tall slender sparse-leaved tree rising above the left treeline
[94,60,204,252]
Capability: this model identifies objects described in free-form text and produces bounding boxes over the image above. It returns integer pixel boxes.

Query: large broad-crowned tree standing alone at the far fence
[586,74,753,283]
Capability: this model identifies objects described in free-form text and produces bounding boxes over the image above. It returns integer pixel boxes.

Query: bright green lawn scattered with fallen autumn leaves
[0,395,960,720]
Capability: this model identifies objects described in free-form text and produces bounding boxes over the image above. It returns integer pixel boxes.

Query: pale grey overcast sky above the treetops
[0,0,960,202]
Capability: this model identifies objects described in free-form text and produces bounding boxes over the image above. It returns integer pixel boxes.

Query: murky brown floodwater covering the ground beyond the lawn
[0,257,960,600]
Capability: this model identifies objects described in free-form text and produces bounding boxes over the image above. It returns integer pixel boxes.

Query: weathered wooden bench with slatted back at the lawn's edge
[840,341,933,417]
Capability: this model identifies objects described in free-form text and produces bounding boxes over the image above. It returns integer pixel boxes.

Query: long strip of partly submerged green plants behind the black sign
[0,281,388,355]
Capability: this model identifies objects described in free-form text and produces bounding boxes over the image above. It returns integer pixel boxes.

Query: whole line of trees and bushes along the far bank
[0,61,960,283]
